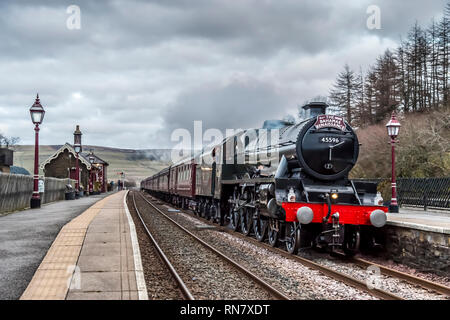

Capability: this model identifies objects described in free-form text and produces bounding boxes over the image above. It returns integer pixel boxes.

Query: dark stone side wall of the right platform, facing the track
[384,226,450,276]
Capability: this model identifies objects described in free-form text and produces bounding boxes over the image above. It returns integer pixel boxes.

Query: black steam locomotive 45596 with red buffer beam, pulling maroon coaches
[141,103,387,255]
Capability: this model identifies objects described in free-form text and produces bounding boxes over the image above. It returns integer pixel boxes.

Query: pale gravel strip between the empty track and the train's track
[143,197,376,300]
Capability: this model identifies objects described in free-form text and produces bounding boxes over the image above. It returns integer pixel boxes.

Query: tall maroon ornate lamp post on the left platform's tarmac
[30,94,45,208]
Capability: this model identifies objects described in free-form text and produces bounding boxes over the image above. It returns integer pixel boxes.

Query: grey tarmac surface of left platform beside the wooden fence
[0,194,110,300]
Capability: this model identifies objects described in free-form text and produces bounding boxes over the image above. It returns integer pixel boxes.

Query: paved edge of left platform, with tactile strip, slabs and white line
[21,191,147,300]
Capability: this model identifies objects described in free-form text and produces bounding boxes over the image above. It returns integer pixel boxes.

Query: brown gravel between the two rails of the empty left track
[131,195,273,300]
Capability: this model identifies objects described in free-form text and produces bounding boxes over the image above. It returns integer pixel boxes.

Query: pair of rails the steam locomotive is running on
[142,192,450,300]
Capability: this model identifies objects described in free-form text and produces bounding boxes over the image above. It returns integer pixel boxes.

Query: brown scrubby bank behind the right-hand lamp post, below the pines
[351,108,450,178]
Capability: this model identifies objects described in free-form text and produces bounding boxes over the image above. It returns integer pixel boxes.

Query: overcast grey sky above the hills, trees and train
[0,0,445,149]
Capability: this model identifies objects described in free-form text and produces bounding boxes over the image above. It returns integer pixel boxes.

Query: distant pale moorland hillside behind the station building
[14,145,170,182]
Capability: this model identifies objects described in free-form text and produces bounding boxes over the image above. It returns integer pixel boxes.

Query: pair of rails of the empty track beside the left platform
[132,192,289,300]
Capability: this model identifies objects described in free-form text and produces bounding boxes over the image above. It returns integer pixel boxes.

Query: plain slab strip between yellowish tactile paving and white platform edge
[67,191,146,300]
